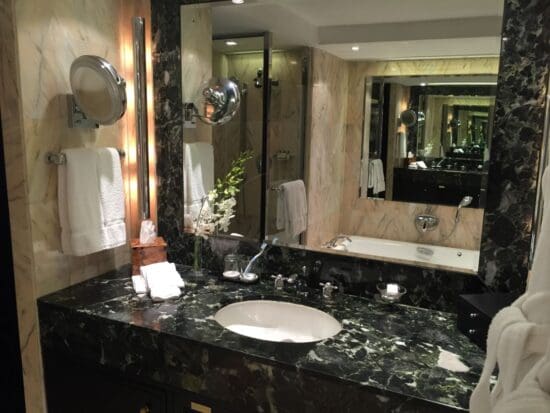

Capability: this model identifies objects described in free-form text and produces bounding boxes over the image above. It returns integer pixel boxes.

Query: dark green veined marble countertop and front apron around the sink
[39,271,484,412]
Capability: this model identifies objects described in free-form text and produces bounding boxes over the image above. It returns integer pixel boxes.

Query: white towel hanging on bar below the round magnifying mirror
[58,148,126,256]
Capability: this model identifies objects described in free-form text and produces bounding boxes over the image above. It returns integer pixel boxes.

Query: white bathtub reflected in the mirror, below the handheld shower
[331,235,479,274]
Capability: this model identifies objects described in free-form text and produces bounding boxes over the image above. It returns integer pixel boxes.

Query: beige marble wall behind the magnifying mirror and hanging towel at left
[0,0,150,412]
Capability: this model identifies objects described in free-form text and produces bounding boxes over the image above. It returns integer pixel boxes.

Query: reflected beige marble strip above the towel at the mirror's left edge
[180,5,212,143]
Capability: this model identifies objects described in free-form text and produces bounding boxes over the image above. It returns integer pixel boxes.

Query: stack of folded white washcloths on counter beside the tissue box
[132,261,185,301]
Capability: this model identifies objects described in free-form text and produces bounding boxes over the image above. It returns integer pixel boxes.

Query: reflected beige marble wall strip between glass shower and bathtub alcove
[306,49,350,247]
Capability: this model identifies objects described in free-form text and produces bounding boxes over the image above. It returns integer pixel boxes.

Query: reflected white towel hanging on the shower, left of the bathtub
[277,179,307,237]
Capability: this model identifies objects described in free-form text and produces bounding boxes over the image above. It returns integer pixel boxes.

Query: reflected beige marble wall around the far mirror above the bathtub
[340,58,498,249]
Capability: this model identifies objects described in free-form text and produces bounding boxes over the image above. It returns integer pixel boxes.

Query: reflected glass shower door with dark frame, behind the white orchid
[212,33,270,239]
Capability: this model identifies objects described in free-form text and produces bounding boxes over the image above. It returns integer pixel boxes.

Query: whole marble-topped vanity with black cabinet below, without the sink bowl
[39,267,484,413]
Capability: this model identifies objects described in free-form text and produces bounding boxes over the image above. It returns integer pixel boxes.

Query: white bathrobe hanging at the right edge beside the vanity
[470,168,550,413]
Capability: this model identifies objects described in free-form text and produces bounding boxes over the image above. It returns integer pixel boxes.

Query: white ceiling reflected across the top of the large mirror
[212,0,503,60]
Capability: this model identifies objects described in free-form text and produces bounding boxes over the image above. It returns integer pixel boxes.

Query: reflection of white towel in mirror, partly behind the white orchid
[183,142,214,228]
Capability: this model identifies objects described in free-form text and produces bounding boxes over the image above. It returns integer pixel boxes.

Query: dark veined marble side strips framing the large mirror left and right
[151,0,550,291]
